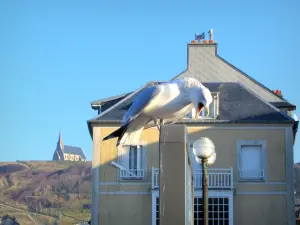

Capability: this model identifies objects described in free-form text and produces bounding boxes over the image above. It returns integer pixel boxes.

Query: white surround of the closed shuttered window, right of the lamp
[237,140,267,182]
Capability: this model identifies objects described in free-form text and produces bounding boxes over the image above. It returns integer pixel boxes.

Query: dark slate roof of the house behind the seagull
[89,82,294,123]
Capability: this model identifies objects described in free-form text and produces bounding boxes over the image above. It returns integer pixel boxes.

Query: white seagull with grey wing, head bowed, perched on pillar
[103,77,212,147]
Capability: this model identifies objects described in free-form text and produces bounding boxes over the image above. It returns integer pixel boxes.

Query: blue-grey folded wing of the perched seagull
[122,85,161,125]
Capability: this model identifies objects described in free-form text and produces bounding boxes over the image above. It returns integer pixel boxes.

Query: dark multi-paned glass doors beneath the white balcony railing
[155,197,230,225]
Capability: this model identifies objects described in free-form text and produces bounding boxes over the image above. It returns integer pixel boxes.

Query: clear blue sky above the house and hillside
[0,0,300,161]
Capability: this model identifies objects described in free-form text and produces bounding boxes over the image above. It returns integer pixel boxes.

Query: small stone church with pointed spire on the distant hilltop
[52,133,86,161]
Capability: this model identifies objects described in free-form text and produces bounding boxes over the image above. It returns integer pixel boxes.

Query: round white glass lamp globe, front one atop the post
[193,137,215,159]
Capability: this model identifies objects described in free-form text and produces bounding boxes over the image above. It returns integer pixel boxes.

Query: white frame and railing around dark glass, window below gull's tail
[118,145,146,180]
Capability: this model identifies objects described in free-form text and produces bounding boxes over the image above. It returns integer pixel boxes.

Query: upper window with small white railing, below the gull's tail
[119,145,145,180]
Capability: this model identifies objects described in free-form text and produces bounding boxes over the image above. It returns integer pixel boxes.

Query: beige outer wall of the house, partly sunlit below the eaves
[93,125,290,225]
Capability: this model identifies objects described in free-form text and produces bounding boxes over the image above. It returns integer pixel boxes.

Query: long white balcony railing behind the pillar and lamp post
[152,168,233,189]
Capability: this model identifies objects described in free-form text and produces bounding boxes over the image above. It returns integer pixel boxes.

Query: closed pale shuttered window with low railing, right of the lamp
[238,141,265,180]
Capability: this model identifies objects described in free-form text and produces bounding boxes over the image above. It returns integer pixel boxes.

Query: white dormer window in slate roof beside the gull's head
[186,93,219,119]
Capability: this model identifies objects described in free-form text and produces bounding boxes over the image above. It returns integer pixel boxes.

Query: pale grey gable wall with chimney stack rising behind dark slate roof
[173,43,295,107]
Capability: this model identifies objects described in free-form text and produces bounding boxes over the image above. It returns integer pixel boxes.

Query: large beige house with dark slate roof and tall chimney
[88,33,297,225]
